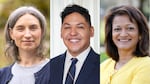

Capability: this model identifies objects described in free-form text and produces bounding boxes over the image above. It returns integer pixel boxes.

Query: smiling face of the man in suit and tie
[61,12,94,56]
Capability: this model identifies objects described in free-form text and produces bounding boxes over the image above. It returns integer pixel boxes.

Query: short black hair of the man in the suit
[60,4,91,26]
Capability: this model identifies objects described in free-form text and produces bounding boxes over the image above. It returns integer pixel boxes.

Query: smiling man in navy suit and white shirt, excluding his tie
[50,4,100,84]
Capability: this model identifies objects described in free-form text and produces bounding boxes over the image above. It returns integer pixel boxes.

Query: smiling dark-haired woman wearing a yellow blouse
[100,6,150,84]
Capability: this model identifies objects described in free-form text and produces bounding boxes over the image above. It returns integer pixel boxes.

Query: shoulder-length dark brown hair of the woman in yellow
[105,5,149,61]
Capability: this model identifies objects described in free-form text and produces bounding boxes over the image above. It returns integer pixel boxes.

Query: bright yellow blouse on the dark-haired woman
[100,56,150,84]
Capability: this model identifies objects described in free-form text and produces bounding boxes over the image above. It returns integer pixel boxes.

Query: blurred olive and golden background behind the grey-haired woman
[0,0,50,68]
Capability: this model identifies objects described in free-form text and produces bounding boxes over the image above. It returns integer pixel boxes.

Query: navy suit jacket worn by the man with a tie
[50,48,100,84]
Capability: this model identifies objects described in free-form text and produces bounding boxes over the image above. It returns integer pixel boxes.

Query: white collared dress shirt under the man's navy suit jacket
[63,46,91,84]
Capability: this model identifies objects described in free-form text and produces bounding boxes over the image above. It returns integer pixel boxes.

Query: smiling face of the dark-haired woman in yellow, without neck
[112,15,139,52]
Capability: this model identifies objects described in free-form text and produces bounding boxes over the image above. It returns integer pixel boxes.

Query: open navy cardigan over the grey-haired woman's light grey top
[0,62,50,84]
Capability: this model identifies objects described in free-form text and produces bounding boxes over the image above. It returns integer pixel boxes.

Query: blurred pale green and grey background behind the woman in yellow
[100,0,150,62]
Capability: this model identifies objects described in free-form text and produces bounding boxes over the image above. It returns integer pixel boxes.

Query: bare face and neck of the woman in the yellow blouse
[112,15,140,69]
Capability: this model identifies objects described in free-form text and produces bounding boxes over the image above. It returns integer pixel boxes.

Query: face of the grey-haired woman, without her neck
[10,14,41,51]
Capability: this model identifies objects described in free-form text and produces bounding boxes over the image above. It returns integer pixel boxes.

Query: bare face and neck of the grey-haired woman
[10,14,42,66]
